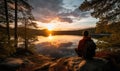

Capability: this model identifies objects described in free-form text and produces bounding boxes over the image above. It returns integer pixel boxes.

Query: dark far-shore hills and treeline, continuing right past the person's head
[0,26,109,38]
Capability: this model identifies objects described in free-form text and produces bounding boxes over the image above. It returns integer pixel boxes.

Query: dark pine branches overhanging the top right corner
[79,0,120,22]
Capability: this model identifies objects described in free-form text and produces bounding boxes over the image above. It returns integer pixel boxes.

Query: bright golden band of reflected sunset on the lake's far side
[35,33,82,44]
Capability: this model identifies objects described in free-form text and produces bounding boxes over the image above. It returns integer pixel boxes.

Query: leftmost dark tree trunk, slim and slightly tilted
[4,0,10,45]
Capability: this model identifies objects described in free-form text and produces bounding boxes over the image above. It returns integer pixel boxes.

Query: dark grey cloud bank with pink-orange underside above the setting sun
[29,0,89,23]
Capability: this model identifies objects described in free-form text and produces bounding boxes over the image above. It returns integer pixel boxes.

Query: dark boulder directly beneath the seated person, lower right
[79,58,113,71]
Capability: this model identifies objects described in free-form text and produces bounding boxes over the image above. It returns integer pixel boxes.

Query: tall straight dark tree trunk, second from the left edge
[14,0,18,48]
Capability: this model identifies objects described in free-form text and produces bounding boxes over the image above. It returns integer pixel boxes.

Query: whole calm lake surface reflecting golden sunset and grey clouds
[35,34,96,58]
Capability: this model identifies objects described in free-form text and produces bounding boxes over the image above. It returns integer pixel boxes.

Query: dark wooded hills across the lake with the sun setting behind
[0,26,95,35]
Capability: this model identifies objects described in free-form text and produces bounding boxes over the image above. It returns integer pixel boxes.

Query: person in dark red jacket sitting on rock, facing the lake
[75,31,96,58]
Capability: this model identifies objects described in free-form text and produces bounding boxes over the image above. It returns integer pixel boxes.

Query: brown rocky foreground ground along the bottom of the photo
[0,55,116,71]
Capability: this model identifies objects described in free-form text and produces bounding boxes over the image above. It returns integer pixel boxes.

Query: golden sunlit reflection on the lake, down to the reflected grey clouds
[35,33,82,46]
